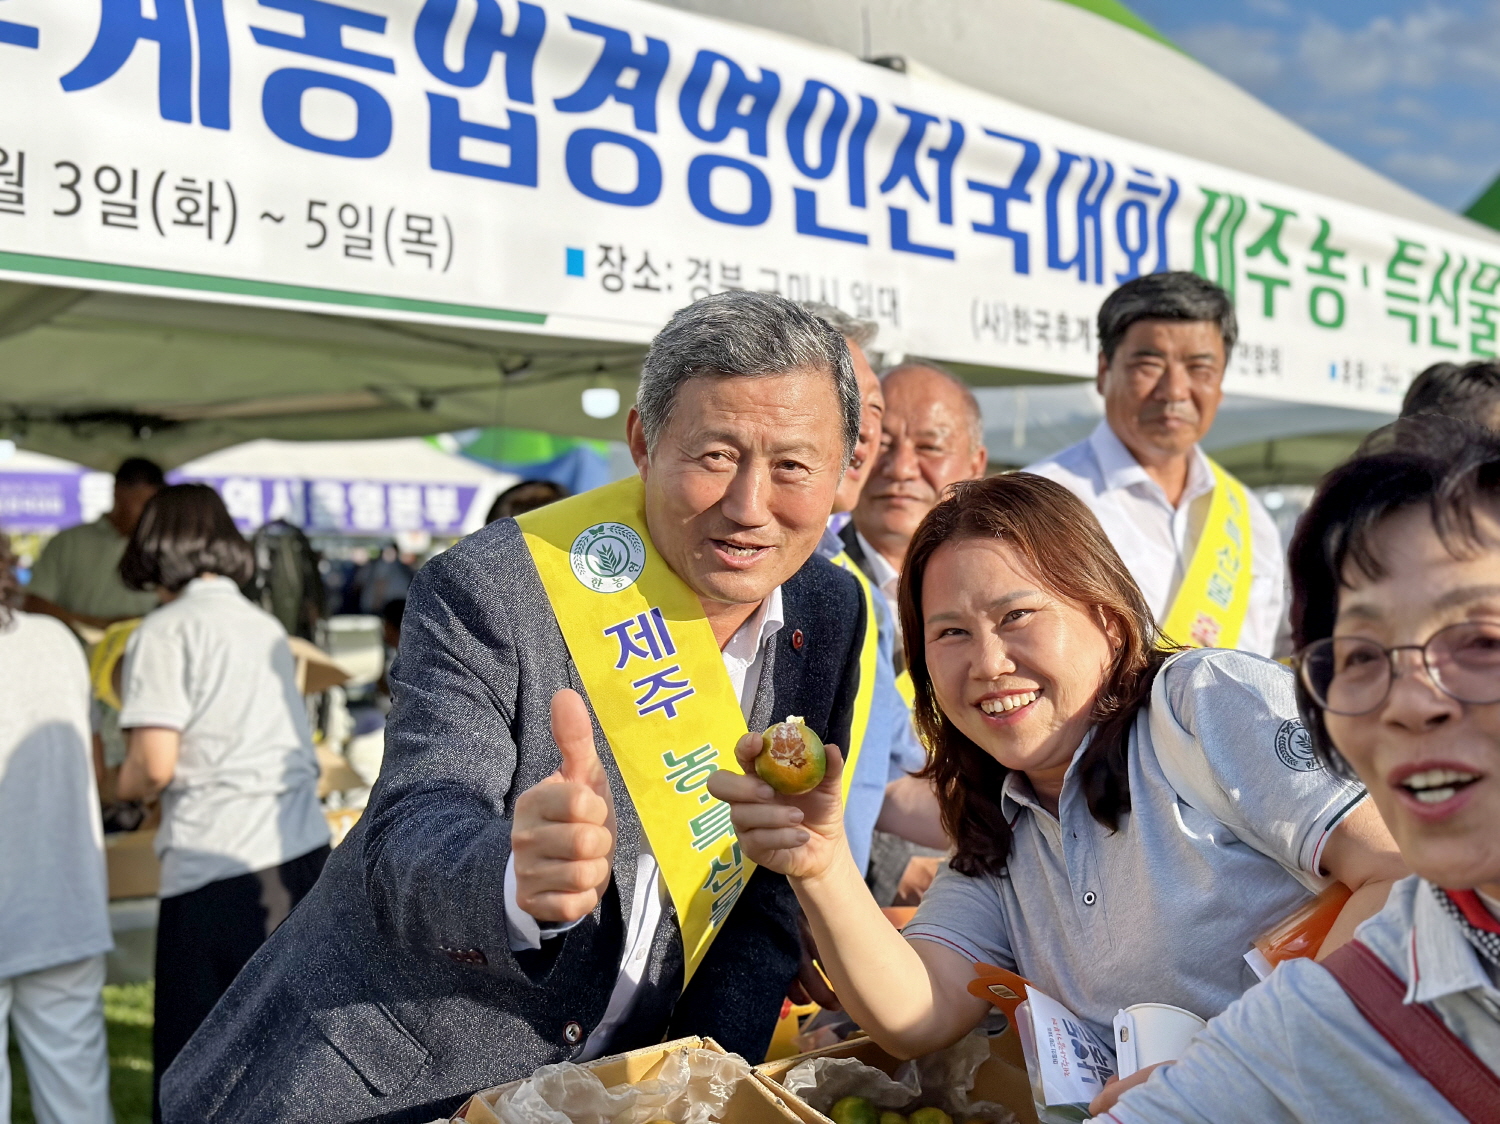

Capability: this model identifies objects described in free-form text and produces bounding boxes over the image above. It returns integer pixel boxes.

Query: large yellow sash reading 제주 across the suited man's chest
[516,477,876,984]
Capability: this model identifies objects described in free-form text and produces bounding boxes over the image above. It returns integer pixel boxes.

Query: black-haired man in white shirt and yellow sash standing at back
[1026,273,1286,656]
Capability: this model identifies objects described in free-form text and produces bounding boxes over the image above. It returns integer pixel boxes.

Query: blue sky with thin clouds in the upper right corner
[1127,0,1500,210]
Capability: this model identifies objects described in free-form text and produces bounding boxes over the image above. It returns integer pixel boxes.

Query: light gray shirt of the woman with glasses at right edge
[1097,875,1500,1124]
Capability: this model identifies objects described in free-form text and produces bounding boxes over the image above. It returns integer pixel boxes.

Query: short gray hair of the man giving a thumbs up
[636,290,860,464]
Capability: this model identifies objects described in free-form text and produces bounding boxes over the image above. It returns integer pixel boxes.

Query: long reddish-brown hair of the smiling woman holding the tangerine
[900,473,1170,875]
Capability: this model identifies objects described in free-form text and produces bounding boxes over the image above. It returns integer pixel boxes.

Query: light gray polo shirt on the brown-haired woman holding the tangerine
[906,648,1365,1043]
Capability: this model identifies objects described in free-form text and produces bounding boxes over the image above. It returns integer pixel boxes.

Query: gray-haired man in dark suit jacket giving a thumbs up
[162,293,873,1124]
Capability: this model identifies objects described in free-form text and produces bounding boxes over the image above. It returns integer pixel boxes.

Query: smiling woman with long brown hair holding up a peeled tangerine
[710,473,1404,1056]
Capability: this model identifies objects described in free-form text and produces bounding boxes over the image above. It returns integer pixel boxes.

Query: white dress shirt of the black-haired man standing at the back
[1026,420,1286,656]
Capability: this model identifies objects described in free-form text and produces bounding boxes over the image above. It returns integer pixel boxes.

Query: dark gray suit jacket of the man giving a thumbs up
[162,519,866,1124]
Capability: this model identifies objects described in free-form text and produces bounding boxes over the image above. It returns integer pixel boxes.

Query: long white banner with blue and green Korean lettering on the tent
[0,0,1500,408]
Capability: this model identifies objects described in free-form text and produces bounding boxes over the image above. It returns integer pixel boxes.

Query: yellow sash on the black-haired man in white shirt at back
[1161,461,1253,648]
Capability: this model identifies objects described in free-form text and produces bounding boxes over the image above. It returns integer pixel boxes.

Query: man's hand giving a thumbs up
[510,689,615,921]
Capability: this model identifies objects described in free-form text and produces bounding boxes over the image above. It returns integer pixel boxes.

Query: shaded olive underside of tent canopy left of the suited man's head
[0,282,645,468]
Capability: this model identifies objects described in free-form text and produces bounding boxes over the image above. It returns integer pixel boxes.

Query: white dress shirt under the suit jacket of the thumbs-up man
[506,585,786,1061]
